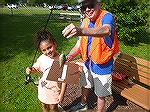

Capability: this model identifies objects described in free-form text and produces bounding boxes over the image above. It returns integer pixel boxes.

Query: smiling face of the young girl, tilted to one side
[39,40,56,58]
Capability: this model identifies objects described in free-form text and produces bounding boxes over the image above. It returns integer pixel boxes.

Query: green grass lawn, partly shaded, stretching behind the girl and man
[0,8,150,112]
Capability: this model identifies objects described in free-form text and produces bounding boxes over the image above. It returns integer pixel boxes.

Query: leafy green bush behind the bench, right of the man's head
[102,0,148,44]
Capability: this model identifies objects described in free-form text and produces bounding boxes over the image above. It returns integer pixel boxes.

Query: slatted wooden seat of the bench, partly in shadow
[113,81,150,110]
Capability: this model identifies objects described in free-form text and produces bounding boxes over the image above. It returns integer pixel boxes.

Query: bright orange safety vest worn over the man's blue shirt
[80,10,119,64]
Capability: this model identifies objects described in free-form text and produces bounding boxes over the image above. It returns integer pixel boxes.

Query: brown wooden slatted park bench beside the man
[112,53,150,110]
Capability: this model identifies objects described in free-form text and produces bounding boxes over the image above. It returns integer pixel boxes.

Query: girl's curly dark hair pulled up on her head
[35,29,56,48]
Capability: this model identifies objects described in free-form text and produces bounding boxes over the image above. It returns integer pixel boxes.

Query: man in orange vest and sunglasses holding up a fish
[62,0,119,112]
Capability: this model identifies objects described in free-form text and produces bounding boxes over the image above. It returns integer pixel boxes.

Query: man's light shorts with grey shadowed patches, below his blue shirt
[80,65,112,97]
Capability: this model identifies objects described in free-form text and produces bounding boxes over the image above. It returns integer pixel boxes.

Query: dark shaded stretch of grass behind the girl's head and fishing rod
[0,15,78,62]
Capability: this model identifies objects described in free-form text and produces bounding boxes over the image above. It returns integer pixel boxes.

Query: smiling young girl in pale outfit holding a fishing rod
[26,30,66,112]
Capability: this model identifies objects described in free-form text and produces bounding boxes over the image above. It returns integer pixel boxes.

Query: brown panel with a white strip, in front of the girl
[47,60,82,84]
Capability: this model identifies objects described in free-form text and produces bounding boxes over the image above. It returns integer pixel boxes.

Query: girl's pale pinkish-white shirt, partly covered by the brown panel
[33,54,60,104]
